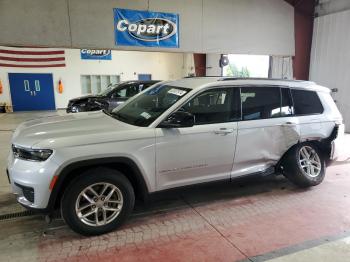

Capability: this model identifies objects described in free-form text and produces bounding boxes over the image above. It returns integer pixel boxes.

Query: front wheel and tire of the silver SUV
[61,168,135,236]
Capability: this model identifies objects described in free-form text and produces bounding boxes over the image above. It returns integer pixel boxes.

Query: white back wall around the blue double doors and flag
[0,49,194,108]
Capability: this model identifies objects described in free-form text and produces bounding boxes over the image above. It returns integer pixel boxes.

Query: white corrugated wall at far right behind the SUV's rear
[310,10,350,132]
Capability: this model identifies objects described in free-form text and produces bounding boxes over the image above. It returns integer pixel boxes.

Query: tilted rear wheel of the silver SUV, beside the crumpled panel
[283,142,325,187]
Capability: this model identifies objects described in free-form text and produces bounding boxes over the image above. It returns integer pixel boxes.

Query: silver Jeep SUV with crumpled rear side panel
[8,77,344,235]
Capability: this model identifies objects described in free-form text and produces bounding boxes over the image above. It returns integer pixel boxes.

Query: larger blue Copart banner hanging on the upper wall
[113,8,179,48]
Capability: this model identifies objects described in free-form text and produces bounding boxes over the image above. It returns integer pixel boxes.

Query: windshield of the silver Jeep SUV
[112,85,191,126]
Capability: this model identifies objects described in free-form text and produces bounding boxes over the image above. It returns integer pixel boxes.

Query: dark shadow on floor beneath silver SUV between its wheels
[133,175,300,217]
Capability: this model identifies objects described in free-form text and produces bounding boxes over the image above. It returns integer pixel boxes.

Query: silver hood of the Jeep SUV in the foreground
[12,111,139,148]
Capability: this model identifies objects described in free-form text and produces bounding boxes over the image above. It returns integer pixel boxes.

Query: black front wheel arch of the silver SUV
[48,159,148,209]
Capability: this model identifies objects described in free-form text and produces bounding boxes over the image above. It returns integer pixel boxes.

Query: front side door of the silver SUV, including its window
[156,87,240,190]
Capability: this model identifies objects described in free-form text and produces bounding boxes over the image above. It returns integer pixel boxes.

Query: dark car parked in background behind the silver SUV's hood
[66,80,160,113]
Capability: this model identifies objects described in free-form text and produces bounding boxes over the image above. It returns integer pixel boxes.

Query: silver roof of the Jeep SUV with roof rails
[168,76,329,92]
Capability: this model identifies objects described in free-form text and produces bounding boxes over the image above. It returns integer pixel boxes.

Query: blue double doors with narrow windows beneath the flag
[9,73,56,111]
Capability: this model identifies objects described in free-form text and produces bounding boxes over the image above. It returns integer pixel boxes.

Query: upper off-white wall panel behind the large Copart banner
[0,0,294,55]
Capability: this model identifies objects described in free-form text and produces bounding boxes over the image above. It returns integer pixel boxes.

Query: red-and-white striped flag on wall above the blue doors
[0,46,66,68]
